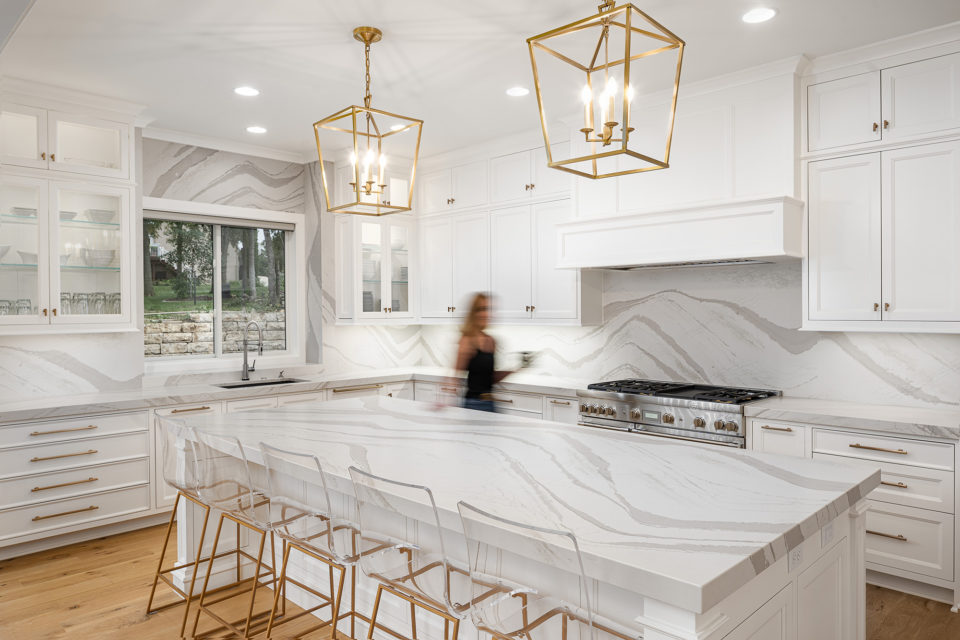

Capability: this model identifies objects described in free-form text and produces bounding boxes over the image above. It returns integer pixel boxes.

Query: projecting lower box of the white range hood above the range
[556,196,803,269]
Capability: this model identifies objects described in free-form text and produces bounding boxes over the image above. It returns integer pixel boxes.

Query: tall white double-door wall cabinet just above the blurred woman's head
[419,211,490,318]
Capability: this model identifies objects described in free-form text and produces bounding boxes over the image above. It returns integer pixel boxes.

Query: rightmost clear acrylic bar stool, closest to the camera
[457,502,643,640]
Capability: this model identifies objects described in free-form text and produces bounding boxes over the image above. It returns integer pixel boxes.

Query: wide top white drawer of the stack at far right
[813,429,953,471]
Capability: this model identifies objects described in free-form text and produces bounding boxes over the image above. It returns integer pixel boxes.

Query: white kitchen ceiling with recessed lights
[0,0,960,160]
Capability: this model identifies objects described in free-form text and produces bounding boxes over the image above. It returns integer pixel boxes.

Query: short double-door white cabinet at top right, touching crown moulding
[806,53,960,153]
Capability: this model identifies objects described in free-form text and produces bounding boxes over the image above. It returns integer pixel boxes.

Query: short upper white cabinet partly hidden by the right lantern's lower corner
[490,147,571,203]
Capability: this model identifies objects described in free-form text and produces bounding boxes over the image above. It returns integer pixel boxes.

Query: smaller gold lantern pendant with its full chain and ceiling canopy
[313,27,423,216]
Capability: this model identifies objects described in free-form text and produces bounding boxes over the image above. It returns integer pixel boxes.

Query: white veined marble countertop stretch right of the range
[744,397,960,440]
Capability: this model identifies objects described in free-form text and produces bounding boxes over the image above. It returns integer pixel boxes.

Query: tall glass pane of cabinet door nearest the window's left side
[56,189,125,316]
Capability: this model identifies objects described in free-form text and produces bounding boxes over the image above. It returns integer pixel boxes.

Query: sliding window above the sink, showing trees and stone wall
[143,211,293,359]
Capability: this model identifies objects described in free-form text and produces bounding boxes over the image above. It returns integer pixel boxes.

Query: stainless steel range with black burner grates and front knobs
[577,380,780,448]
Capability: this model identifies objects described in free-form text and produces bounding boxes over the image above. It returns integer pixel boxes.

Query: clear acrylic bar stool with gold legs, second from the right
[350,467,469,640]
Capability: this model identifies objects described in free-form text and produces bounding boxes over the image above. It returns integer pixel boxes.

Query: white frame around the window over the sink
[136,196,307,376]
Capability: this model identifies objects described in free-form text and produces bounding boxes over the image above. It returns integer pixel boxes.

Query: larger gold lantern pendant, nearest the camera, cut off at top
[527,0,684,179]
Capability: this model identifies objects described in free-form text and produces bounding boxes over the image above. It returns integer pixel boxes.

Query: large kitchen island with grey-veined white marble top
[179,397,880,640]
